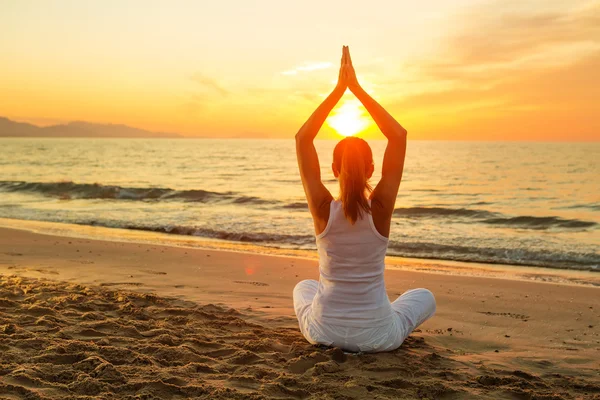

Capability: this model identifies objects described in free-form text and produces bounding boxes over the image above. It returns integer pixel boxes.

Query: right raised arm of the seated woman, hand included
[346,50,407,217]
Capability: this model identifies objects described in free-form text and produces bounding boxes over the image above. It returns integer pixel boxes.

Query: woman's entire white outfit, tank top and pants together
[294,200,436,352]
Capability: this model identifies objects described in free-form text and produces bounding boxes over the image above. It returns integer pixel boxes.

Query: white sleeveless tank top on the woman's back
[312,200,392,327]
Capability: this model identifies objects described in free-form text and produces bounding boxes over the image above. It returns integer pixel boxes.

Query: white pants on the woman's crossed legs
[294,279,436,352]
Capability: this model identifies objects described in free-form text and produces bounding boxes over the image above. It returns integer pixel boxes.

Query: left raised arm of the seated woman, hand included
[296,48,347,234]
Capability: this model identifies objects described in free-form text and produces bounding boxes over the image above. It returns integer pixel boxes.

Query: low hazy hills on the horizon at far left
[0,117,182,138]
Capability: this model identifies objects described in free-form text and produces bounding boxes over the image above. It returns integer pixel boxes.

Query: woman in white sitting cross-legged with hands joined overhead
[294,46,436,352]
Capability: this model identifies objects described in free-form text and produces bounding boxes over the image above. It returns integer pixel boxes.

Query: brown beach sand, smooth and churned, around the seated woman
[0,225,600,399]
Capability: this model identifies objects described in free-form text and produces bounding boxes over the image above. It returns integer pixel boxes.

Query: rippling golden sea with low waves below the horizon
[0,138,600,271]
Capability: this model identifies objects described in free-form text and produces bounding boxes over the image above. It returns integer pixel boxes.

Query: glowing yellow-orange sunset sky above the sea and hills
[0,0,600,141]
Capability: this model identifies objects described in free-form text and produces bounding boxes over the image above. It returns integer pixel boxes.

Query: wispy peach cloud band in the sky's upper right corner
[420,1,600,80]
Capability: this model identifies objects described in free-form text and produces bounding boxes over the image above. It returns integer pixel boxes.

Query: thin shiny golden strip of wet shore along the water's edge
[0,218,600,287]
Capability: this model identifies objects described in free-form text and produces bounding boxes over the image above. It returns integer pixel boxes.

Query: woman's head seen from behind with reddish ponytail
[331,137,373,224]
